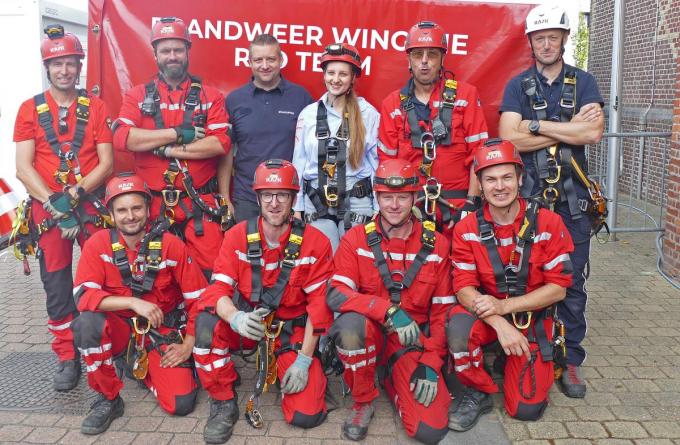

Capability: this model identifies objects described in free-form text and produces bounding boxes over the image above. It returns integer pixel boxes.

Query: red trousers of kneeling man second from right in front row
[329,312,451,442]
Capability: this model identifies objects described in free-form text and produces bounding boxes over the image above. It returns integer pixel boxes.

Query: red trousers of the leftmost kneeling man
[73,312,198,415]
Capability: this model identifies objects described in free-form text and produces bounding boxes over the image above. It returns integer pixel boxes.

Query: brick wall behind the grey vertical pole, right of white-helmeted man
[588,0,680,204]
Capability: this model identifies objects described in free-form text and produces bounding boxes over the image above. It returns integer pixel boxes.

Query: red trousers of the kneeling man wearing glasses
[194,312,326,428]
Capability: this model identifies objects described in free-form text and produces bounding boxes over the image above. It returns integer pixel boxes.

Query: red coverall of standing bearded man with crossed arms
[113,77,231,276]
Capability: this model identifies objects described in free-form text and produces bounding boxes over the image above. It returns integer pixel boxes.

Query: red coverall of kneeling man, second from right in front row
[327,217,455,443]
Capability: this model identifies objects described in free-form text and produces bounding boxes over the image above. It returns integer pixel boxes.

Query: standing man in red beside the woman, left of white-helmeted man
[378,21,489,236]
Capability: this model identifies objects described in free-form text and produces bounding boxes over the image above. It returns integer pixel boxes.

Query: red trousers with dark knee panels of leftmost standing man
[31,199,101,361]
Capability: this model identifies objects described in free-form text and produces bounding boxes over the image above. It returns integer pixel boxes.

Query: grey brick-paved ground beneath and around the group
[0,224,680,445]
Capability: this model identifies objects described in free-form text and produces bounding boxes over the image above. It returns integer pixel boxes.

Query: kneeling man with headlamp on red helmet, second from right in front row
[327,159,455,444]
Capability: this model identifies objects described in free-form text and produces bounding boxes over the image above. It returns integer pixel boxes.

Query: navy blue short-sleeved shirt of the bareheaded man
[227,77,312,202]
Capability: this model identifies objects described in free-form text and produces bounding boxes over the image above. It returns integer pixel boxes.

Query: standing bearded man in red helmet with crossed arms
[113,17,231,278]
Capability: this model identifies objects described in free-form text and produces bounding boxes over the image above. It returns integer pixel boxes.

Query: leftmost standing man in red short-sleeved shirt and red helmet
[14,25,113,391]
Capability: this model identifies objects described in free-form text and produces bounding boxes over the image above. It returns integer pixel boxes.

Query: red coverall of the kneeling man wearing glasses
[194,218,333,428]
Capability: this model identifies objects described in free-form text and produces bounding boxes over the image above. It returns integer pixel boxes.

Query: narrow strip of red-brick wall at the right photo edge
[663,57,680,280]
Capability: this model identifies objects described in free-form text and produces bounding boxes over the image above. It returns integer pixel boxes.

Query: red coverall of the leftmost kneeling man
[73,229,207,415]
